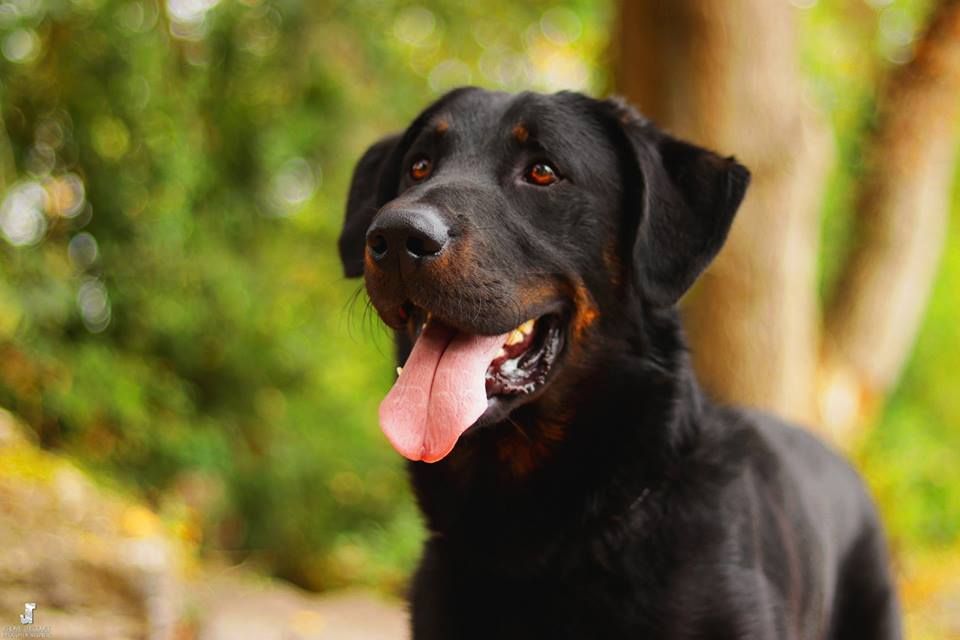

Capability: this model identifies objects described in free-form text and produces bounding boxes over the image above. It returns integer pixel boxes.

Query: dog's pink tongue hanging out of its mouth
[380,322,507,462]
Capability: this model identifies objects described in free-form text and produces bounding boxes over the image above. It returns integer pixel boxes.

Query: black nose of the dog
[367,207,450,262]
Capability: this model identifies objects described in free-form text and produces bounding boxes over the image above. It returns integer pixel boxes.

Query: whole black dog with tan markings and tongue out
[340,89,900,640]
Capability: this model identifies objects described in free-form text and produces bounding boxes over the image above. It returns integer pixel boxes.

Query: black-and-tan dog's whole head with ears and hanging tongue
[340,88,749,462]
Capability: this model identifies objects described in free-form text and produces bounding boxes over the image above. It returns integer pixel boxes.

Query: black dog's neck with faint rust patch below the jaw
[402,310,707,534]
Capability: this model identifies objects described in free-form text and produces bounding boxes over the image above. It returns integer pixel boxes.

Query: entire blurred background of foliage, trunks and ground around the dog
[0,0,960,639]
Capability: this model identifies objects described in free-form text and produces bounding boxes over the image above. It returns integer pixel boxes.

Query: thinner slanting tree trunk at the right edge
[823,0,960,437]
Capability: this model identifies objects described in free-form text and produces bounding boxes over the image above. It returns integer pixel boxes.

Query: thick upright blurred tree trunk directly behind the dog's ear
[616,0,833,430]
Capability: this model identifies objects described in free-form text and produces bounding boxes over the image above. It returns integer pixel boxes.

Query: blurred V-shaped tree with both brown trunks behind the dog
[616,0,960,441]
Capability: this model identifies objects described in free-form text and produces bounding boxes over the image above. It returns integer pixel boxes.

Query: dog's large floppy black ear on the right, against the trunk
[601,99,750,307]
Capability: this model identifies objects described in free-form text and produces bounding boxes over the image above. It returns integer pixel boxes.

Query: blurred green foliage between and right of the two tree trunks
[801,0,960,550]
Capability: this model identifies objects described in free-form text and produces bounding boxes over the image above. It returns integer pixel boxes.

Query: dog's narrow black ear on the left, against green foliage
[338,134,400,278]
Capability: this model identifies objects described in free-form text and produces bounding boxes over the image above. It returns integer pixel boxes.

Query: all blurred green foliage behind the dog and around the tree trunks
[0,0,960,588]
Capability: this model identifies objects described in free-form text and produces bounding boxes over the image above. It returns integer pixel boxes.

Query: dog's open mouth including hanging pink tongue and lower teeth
[380,305,564,462]
